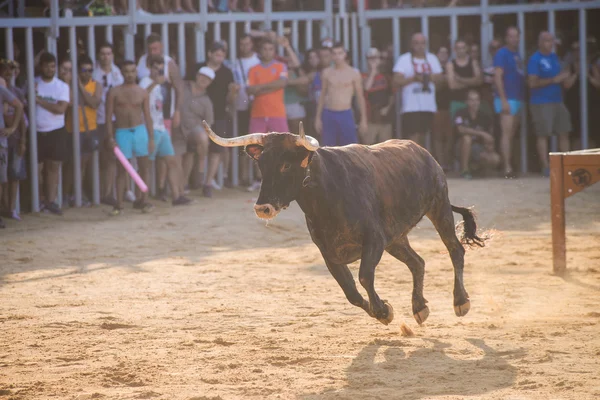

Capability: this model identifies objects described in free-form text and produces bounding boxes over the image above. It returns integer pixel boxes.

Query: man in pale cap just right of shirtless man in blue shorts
[360,47,394,144]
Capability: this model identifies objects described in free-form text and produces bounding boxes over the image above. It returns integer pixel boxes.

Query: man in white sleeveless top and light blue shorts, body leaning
[140,56,191,206]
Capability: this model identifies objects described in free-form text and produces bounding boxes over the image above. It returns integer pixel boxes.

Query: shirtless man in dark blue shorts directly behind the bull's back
[315,43,367,146]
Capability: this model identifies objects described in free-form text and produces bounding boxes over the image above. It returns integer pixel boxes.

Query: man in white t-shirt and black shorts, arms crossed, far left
[35,53,71,215]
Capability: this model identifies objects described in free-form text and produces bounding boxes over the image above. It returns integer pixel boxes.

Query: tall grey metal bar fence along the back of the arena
[0,0,600,212]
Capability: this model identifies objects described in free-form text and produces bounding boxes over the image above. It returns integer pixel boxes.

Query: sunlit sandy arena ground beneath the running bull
[0,178,600,400]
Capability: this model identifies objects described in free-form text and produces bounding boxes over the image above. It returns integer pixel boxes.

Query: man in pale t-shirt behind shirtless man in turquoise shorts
[92,43,123,206]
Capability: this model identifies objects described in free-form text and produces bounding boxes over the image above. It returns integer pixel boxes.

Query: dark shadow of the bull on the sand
[302,339,523,400]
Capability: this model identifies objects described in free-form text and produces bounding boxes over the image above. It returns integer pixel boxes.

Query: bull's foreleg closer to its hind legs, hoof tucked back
[358,235,394,325]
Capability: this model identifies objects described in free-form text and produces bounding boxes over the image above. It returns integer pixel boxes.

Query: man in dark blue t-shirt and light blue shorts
[494,26,525,178]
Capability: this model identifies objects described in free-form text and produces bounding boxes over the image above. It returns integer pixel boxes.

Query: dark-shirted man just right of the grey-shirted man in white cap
[194,42,240,197]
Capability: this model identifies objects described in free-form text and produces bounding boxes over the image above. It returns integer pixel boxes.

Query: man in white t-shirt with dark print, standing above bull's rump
[394,33,444,145]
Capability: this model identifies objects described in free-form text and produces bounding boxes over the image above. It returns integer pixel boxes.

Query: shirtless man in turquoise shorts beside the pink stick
[106,61,154,215]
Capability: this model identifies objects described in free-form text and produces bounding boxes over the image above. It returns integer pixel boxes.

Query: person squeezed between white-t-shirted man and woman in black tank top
[432,46,454,171]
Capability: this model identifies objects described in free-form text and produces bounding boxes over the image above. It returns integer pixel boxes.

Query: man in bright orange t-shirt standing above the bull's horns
[246,38,289,133]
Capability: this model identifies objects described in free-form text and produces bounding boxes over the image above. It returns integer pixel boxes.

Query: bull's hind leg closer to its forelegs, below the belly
[386,237,429,325]
